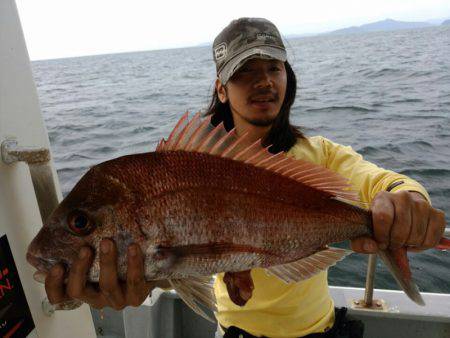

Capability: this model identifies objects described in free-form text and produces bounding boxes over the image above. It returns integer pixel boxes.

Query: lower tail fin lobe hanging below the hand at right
[378,248,425,306]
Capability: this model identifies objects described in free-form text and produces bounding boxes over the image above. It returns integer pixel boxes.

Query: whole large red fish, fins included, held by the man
[27,116,448,320]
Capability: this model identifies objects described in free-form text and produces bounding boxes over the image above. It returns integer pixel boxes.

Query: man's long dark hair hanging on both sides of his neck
[205,61,305,153]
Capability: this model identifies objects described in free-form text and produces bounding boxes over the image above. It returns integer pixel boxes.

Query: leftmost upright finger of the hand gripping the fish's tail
[371,192,395,249]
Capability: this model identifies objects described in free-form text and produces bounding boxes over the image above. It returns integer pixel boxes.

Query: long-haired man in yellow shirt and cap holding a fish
[46,18,445,337]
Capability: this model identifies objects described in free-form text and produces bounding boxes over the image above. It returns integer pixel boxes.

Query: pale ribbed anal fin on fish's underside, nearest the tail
[266,248,352,283]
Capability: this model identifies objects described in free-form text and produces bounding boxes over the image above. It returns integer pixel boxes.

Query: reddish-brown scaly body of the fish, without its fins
[30,151,370,281]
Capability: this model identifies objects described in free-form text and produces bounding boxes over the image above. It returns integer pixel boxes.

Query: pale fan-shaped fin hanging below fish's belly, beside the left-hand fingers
[169,276,217,323]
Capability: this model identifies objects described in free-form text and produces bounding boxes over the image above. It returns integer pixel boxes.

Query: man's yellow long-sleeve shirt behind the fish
[215,136,429,337]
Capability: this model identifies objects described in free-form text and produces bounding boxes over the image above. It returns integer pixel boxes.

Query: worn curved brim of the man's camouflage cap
[218,46,287,85]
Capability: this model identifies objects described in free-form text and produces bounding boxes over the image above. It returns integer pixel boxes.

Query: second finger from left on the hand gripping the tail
[389,191,413,249]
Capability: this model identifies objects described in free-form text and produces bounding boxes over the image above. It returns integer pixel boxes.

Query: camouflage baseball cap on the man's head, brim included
[213,18,287,84]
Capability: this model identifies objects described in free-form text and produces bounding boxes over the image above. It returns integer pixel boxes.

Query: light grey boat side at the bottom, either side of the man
[92,287,450,338]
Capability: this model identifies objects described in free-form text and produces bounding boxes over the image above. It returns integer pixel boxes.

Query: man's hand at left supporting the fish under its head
[45,239,168,310]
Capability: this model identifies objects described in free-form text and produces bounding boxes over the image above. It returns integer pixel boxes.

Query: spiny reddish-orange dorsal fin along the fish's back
[156,112,359,202]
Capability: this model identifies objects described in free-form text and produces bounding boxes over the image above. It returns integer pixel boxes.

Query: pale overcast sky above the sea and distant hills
[16,0,450,60]
